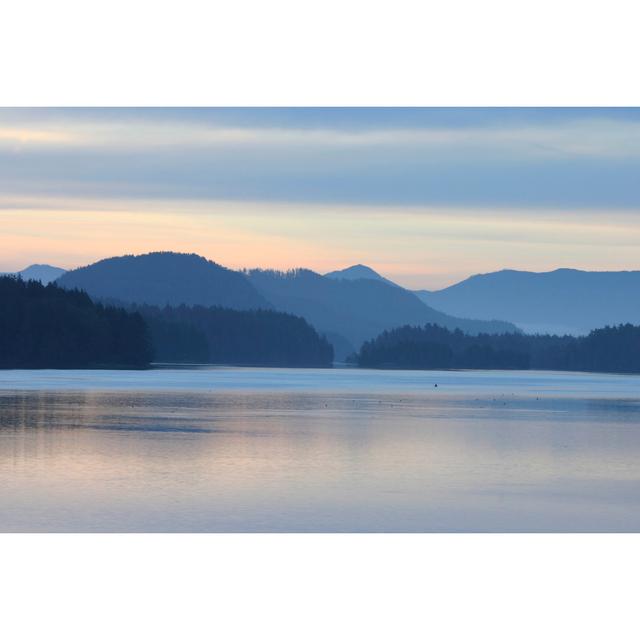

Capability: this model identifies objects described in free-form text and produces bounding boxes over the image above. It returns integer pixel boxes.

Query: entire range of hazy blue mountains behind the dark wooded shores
[10,252,640,359]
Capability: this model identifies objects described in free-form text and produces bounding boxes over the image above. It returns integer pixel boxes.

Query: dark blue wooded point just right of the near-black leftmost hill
[133,305,333,367]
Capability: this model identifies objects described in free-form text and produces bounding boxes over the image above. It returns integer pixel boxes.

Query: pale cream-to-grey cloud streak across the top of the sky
[0,111,640,158]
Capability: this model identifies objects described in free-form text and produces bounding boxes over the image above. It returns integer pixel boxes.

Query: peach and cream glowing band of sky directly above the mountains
[0,199,640,288]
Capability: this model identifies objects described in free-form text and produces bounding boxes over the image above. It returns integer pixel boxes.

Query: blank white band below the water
[0,534,640,640]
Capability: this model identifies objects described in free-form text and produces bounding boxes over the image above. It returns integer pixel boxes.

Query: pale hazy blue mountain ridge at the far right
[416,269,640,335]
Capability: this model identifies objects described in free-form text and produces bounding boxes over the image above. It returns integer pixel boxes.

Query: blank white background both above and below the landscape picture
[0,0,640,640]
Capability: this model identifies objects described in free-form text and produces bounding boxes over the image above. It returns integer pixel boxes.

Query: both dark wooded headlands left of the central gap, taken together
[0,277,333,369]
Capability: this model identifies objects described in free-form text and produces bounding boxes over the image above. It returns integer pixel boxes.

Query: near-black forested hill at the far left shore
[0,277,152,369]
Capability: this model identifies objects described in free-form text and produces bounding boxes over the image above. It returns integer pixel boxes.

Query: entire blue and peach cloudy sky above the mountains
[0,108,640,289]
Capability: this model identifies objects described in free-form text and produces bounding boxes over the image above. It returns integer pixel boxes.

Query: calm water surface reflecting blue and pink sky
[0,367,640,532]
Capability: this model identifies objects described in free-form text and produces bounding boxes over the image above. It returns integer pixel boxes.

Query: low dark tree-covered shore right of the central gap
[353,324,640,373]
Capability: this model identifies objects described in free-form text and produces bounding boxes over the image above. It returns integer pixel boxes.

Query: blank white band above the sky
[0,0,640,106]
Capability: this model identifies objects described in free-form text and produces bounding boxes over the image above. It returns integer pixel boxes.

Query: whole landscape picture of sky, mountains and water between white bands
[0,108,640,533]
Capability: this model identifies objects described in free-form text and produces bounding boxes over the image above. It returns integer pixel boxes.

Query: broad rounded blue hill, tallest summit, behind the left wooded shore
[57,252,271,309]
